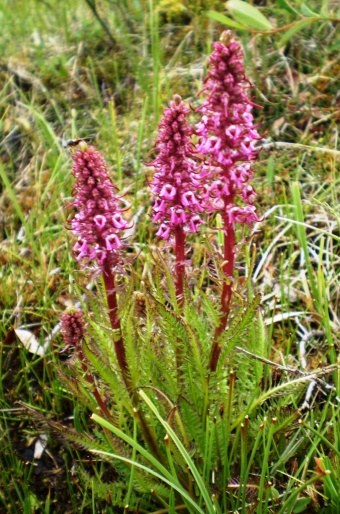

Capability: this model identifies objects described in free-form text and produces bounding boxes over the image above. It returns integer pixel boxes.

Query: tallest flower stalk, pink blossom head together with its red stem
[196,31,261,371]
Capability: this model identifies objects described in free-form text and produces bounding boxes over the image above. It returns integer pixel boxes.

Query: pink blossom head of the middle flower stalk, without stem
[149,95,204,239]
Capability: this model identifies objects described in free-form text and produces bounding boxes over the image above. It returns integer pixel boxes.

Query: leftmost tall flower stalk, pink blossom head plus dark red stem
[70,142,130,387]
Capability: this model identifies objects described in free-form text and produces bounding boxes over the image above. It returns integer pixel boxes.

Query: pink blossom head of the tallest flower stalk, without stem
[196,31,261,223]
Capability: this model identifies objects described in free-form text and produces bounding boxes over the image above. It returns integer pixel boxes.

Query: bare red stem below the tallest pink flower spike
[209,202,235,371]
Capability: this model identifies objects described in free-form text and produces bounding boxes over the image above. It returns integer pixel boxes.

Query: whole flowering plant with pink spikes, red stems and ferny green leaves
[24,33,298,514]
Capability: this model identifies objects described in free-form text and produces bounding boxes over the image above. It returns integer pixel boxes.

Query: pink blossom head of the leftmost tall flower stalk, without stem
[70,142,127,266]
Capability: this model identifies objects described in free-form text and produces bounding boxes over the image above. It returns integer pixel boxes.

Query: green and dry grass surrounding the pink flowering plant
[0,0,340,514]
